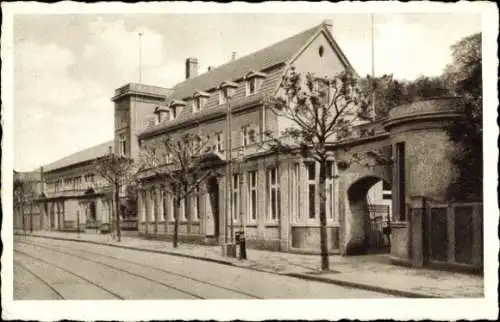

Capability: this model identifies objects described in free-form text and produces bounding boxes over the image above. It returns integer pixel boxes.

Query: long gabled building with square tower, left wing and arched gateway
[18,21,477,272]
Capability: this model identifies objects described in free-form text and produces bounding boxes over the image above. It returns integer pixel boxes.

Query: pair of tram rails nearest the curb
[15,241,263,299]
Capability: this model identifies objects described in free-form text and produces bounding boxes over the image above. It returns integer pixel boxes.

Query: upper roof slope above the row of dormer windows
[170,25,322,99]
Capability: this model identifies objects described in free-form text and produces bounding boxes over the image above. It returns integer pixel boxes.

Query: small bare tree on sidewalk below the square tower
[94,152,139,241]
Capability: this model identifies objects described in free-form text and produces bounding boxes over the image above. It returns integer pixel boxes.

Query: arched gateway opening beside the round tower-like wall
[345,176,392,255]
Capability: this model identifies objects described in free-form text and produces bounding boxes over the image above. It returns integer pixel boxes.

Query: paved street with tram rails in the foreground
[14,237,390,299]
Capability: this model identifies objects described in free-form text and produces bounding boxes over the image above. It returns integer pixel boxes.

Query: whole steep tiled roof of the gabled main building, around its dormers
[139,22,354,138]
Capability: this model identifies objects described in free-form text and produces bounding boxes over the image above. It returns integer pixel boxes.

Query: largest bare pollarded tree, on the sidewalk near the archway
[265,67,392,270]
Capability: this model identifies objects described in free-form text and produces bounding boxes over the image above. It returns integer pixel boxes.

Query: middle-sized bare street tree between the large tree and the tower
[142,133,212,248]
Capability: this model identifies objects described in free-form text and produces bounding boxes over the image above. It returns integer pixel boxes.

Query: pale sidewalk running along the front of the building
[15,231,484,298]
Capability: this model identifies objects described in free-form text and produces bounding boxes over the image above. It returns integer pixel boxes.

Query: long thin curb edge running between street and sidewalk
[15,233,442,298]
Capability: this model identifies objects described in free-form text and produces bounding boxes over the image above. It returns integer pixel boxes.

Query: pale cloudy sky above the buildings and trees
[13,14,481,170]
